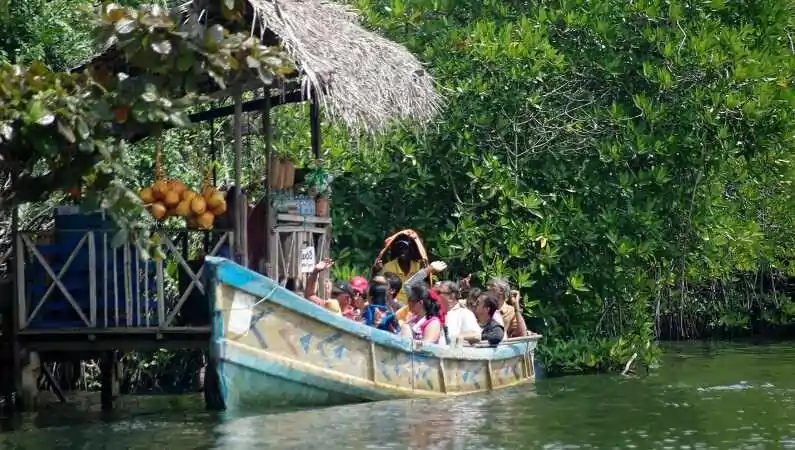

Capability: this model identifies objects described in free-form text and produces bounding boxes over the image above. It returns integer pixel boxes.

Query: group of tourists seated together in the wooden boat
[304,237,532,346]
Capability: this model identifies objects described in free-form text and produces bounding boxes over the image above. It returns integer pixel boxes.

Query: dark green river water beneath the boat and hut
[0,344,795,450]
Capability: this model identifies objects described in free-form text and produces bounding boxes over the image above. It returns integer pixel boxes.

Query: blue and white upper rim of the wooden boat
[205,256,541,362]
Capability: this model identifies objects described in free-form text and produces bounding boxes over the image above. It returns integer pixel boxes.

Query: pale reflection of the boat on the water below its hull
[215,395,520,450]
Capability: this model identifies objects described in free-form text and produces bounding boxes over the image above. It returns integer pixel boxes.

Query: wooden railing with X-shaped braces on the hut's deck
[14,229,233,331]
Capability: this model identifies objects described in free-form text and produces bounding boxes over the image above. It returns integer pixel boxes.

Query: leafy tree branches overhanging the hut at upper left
[0,5,293,237]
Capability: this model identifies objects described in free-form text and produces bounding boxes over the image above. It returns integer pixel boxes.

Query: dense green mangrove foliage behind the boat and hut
[0,0,795,373]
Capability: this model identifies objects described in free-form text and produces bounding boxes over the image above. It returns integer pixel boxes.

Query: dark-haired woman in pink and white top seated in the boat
[401,282,446,345]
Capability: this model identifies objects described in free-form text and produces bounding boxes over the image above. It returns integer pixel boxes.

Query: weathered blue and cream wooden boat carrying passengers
[205,258,538,409]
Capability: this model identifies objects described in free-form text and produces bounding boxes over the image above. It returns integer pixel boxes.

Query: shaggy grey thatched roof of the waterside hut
[80,0,442,132]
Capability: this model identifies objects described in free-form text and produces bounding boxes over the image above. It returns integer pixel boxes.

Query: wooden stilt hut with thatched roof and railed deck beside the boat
[0,0,441,412]
